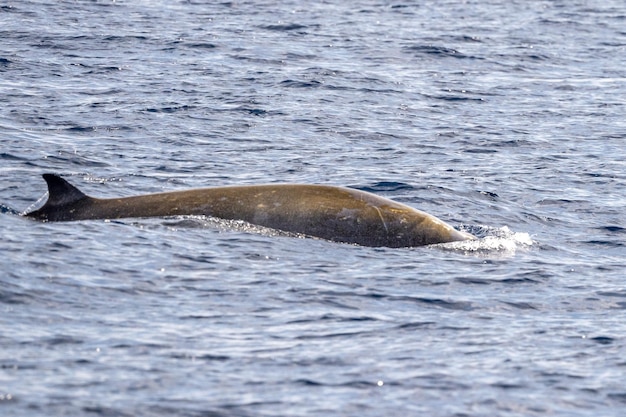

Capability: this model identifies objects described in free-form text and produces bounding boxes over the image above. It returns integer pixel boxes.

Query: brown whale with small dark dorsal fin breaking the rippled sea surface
[24,174,476,248]
